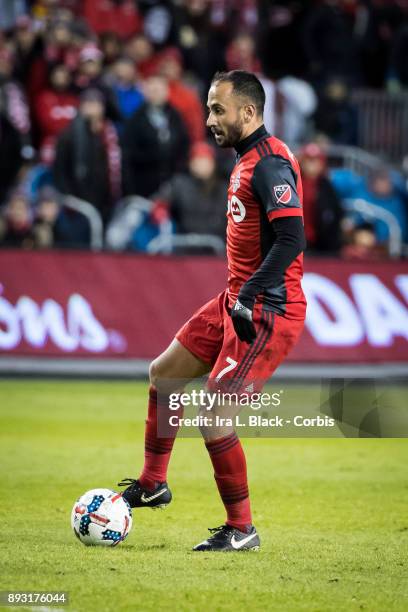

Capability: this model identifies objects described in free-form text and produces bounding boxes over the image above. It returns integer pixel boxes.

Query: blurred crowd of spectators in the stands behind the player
[0,0,408,259]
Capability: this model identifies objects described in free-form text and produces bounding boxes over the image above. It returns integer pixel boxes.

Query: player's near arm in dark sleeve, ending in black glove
[231,156,306,343]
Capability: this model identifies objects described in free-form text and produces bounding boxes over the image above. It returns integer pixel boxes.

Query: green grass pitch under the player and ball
[0,380,408,612]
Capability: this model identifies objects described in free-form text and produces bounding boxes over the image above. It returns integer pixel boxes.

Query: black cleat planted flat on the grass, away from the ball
[193,525,261,552]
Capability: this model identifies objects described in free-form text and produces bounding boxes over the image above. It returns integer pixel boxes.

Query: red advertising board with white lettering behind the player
[0,251,408,362]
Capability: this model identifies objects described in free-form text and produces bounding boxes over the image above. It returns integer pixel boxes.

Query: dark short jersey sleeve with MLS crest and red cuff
[252,155,302,221]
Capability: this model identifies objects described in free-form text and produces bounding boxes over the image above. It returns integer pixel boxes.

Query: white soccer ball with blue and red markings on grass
[71,489,132,546]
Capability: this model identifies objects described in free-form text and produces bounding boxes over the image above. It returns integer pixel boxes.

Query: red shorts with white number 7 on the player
[176,291,304,387]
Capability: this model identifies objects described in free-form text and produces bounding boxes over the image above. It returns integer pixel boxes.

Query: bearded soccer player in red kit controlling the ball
[120,70,306,551]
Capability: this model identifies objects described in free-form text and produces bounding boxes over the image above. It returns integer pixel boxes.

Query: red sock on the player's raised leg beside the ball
[139,386,177,489]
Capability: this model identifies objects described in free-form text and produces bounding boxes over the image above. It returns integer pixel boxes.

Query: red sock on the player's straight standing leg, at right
[205,432,252,532]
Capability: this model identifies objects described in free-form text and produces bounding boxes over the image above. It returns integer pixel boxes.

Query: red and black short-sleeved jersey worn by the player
[227,126,306,319]
